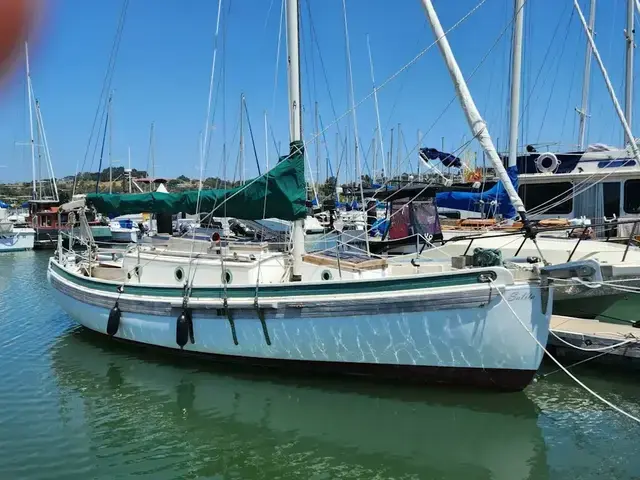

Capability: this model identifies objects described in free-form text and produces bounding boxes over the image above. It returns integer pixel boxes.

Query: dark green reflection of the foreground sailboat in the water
[52,330,547,480]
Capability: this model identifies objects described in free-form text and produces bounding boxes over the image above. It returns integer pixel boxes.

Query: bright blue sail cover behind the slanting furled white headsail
[436,167,518,218]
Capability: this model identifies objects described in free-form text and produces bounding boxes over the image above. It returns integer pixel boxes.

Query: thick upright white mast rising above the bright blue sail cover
[507,0,524,167]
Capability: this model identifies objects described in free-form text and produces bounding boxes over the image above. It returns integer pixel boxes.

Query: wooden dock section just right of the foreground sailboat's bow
[548,315,640,368]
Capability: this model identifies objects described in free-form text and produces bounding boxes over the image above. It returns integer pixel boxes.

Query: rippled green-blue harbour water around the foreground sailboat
[0,252,640,480]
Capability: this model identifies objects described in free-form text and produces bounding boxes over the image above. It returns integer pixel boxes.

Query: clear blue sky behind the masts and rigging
[0,0,640,186]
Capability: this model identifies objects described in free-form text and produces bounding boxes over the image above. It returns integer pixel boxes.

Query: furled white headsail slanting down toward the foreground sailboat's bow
[422,0,526,216]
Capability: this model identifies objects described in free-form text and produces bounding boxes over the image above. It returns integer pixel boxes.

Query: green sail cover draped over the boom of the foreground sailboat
[86,142,307,220]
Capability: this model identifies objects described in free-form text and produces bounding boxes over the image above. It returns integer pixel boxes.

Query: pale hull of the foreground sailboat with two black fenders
[48,260,552,390]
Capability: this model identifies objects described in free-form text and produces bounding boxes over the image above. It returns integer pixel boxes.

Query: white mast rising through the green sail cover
[286,0,304,280]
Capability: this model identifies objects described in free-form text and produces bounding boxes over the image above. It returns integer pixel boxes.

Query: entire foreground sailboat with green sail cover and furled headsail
[47,0,596,390]
